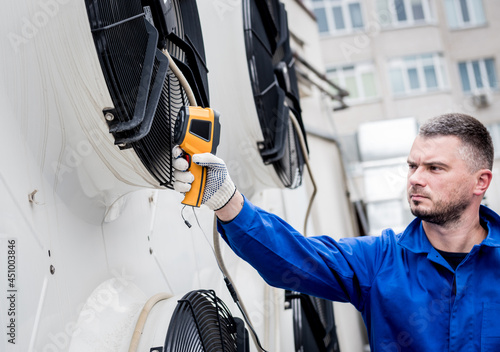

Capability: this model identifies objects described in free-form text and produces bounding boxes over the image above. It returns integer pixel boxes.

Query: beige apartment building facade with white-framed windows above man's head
[310,0,500,134]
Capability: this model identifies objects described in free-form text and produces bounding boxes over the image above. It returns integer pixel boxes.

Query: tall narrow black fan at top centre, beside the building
[243,0,305,188]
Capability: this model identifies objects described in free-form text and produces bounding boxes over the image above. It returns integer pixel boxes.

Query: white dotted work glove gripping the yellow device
[172,146,236,210]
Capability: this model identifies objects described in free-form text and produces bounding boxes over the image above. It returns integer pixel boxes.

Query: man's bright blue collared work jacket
[219,199,500,352]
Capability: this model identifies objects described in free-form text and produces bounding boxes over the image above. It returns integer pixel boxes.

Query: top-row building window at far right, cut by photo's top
[445,0,486,28]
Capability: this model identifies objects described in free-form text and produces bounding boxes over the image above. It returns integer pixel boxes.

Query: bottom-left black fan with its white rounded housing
[66,284,250,352]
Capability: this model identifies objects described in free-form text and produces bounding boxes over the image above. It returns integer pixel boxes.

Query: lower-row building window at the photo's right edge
[458,59,499,93]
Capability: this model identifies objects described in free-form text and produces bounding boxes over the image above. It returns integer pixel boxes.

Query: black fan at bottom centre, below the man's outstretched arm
[285,291,340,352]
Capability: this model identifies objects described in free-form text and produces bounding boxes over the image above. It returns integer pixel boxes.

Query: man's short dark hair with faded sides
[419,113,494,172]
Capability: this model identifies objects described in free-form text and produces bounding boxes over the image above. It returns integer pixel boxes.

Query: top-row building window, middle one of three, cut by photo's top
[376,0,433,26]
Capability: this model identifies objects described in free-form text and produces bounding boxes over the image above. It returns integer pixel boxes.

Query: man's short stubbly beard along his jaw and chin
[410,190,470,226]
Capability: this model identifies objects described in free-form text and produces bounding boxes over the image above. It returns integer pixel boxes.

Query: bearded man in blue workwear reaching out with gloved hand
[175,114,500,352]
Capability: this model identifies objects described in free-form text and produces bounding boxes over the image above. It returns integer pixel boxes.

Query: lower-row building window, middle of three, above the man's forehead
[389,54,448,95]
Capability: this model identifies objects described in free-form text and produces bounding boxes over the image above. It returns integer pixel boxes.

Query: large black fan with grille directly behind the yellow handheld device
[85,0,209,188]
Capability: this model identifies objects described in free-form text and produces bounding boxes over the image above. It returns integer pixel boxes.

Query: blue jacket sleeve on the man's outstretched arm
[218,195,390,310]
